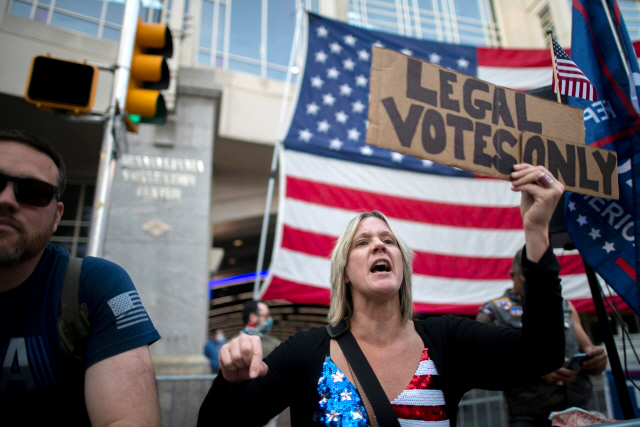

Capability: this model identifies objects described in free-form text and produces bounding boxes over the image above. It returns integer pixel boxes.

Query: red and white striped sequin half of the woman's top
[391,348,449,427]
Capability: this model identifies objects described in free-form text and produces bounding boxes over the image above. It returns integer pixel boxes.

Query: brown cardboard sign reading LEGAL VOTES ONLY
[367,47,618,199]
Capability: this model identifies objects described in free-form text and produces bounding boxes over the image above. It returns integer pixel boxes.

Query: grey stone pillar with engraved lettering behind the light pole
[104,90,217,375]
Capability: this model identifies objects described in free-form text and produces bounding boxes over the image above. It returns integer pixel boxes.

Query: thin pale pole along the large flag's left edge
[253,3,303,300]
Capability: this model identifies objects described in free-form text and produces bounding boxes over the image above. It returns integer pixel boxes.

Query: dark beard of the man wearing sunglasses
[0,208,55,267]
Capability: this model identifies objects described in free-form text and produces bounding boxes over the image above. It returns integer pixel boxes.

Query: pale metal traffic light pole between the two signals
[87,0,140,257]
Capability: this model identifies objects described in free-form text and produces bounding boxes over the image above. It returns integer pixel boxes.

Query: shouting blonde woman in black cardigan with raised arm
[198,164,564,426]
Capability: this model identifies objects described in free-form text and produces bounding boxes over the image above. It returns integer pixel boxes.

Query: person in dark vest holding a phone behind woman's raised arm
[476,250,607,427]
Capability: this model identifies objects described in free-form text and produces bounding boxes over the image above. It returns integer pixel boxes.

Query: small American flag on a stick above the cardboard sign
[551,37,598,102]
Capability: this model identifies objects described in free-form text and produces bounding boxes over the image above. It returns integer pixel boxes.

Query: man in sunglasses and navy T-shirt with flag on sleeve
[0,130,160,426]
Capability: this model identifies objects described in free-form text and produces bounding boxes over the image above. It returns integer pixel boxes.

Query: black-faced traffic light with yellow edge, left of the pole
[24,55,98,114]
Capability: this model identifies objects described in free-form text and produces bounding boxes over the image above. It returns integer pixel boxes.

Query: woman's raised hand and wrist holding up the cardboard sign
[511,163,564,262]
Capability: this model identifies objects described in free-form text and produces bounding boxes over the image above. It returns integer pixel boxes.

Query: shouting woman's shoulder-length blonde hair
[327,211,414,326]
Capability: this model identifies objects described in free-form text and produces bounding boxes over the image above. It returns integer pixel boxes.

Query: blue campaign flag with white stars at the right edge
[565,0,640,314]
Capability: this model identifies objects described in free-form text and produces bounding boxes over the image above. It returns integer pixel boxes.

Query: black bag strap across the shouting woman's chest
[327,320,400,427]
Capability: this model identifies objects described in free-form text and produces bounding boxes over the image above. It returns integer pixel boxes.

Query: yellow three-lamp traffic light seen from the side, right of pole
[125,20,173,125]
